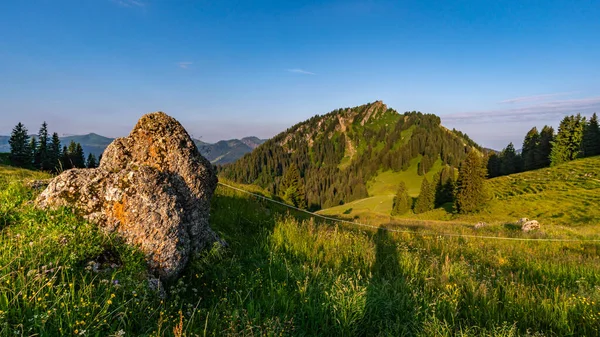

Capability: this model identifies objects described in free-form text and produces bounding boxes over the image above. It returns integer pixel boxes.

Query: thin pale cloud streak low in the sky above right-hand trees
[442,96,600,124]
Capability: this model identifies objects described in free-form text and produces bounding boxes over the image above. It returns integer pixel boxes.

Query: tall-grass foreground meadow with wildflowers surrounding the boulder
[0,166,600,336]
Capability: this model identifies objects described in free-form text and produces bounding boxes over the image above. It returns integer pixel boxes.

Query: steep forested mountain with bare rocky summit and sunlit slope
[220,101,482,210]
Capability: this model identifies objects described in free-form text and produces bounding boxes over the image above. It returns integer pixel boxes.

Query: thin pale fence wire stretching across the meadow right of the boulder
[219,181,600,242]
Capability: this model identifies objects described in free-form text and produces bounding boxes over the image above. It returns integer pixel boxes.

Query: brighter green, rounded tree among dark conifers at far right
[550,114,586,166]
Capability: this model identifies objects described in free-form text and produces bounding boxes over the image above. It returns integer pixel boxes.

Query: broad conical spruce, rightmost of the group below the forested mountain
[454,151,487,213]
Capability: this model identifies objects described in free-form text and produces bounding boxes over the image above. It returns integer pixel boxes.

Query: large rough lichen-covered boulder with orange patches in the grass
[36,112,221,279]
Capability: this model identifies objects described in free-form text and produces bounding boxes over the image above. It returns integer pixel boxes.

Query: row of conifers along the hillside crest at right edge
[487,113,600,178]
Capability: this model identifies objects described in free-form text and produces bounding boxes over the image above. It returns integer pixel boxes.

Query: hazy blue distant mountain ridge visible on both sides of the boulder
[0,133,266,165]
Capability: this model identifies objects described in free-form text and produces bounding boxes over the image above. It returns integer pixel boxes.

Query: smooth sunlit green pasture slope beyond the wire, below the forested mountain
[320,157,600,227]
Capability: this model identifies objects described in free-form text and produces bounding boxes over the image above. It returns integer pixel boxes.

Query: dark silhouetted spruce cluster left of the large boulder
[8,122,102,173]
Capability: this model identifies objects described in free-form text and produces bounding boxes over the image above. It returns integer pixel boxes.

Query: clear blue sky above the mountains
[0,0,600,148]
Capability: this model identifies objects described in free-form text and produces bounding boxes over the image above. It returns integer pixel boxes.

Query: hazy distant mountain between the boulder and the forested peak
[194,137,266,165]
